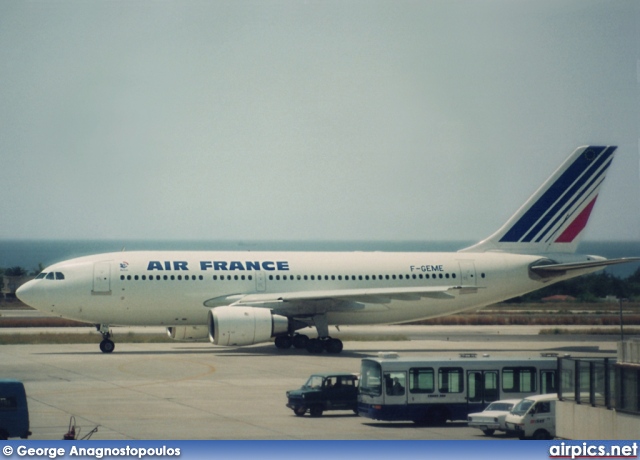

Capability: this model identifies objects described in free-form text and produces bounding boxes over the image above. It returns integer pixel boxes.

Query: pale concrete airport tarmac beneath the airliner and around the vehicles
[0,326,617,440]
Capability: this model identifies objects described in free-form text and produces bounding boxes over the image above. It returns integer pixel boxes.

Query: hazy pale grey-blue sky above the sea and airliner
[0,0,640,241]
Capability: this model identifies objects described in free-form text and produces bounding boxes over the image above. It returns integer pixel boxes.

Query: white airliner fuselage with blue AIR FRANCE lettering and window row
[19,251,595,326]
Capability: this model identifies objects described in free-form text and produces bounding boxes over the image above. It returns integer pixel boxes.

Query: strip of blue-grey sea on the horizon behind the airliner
[0,239,640,278]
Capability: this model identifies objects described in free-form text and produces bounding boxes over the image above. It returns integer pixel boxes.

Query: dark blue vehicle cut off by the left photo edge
[0,379,31,439]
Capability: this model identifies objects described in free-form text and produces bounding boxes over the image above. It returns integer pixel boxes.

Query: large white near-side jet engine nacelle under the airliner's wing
[208,307,289,346]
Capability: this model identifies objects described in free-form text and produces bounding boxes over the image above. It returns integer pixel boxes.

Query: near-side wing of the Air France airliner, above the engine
[204,286,478,315]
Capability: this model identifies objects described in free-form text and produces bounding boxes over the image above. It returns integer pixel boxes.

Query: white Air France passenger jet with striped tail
[17,145,640,353]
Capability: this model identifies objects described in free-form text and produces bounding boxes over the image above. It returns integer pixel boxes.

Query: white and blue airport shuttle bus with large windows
[358,354,558,424]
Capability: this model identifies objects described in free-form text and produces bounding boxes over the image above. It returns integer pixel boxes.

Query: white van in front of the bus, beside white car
[505,394,558,439]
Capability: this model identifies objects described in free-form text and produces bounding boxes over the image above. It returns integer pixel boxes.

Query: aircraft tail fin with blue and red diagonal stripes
[460,145,617,254]
